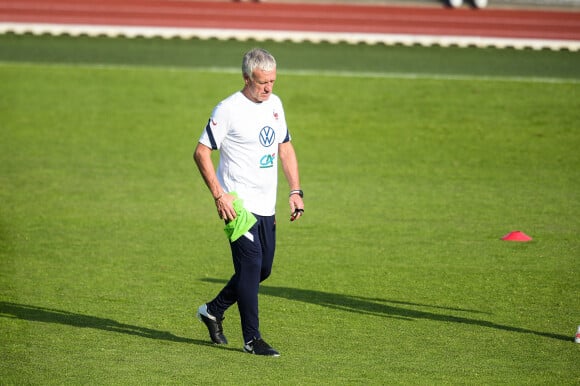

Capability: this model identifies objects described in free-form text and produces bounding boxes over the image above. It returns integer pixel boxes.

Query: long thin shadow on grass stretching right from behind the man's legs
[202,278,573,341]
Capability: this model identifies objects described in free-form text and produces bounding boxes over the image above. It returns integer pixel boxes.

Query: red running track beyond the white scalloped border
[0,0,580,41]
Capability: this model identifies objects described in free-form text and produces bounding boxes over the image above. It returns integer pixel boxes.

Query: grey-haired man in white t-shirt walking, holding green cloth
[194,48,304,356]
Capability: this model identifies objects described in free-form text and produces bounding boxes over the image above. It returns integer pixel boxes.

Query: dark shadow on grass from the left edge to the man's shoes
[0,302,240,351]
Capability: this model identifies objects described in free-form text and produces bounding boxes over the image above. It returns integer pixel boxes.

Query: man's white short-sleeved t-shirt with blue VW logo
[199,91,291,216]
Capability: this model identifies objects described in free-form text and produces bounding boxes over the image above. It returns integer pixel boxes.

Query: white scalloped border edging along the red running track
[0,22,580,51]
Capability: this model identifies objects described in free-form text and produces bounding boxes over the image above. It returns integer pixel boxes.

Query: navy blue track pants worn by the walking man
[207,215,276,343]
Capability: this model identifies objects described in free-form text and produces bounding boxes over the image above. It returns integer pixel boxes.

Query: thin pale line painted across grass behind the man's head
[0,60,580,84]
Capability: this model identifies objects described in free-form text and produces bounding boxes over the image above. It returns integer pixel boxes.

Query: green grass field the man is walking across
[0,36,580,385]
